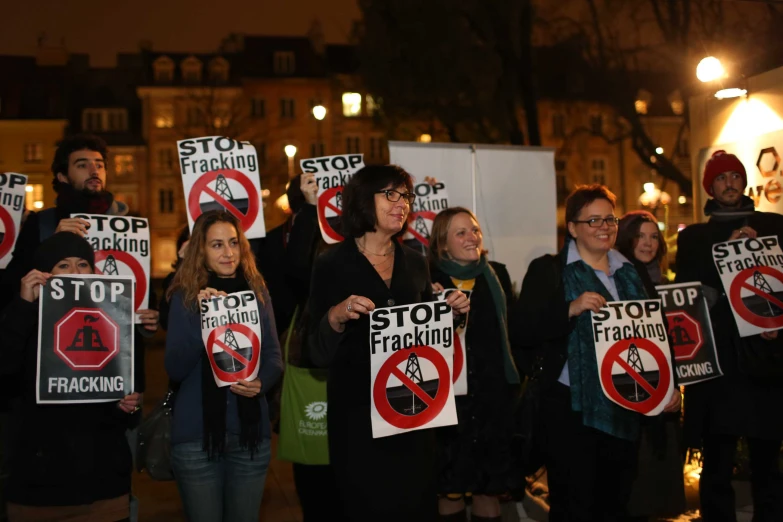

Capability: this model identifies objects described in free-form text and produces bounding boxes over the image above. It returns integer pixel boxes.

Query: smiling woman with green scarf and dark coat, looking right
[429,207,524,521]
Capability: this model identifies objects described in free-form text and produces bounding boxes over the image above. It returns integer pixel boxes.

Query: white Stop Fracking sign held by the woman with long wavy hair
[201,290,262,387]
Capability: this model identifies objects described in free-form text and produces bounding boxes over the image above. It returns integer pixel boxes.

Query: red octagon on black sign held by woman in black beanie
[54,308,120,371]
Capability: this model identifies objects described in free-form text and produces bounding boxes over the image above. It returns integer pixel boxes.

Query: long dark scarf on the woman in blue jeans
[201,272,261,458]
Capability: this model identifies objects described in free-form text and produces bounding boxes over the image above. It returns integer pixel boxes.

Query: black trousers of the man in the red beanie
[699,435,783,522]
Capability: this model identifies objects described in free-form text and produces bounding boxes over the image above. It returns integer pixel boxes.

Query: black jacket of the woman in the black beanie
[0,297,132,506]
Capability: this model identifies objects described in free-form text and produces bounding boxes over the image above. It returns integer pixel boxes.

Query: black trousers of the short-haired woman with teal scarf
[541,383,638,522]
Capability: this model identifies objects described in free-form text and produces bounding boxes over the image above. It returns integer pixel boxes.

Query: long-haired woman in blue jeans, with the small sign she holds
[165,211,283,522]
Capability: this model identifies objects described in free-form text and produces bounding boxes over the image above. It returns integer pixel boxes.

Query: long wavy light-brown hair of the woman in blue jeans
[166,210,266,309]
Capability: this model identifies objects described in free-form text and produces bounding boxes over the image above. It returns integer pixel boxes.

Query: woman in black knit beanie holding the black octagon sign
[0,232,139,522]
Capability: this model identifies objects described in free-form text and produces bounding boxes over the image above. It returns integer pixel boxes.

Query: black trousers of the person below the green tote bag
[294,464,345,522]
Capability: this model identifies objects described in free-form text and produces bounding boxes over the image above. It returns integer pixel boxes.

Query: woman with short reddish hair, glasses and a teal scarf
[509,185,680,522]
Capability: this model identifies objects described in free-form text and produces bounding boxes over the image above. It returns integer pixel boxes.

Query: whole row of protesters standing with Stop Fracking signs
[0,135,783,522]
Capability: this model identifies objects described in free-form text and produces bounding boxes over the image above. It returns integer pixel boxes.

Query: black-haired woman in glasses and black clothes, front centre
[310,165,469,522]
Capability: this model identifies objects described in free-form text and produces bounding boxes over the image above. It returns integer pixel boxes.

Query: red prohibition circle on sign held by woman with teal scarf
[601,337,671,414]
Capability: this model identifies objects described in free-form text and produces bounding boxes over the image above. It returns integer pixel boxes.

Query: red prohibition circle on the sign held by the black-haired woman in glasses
[372,346,451,430]
